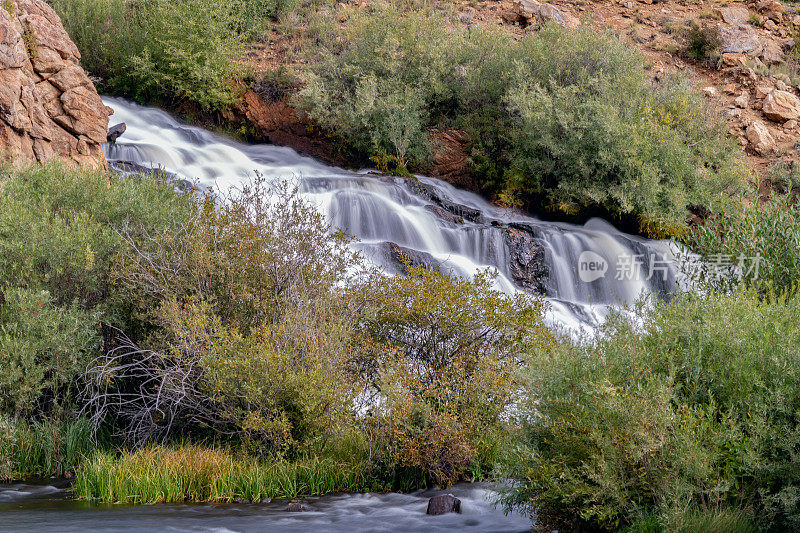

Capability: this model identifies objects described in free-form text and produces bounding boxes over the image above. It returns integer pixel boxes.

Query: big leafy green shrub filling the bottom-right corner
[507,291,800,531]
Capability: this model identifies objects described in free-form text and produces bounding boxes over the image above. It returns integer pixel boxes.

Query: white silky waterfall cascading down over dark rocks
[104,98,677,329]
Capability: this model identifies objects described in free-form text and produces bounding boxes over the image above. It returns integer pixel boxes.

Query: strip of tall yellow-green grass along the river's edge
[74,444,374,504]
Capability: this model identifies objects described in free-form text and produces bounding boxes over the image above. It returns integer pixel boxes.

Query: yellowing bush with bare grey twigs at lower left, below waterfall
[88,178,357,453]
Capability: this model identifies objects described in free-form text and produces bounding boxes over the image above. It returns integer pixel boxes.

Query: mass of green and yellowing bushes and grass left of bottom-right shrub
[0,161,549,494]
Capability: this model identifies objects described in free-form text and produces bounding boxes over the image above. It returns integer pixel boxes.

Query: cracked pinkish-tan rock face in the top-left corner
[0,0,112,167]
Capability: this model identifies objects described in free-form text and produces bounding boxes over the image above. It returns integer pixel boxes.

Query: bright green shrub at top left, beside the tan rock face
[53,0,258,110]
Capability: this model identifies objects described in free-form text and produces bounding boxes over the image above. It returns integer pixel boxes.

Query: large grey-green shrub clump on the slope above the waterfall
[297,8,744,235]
